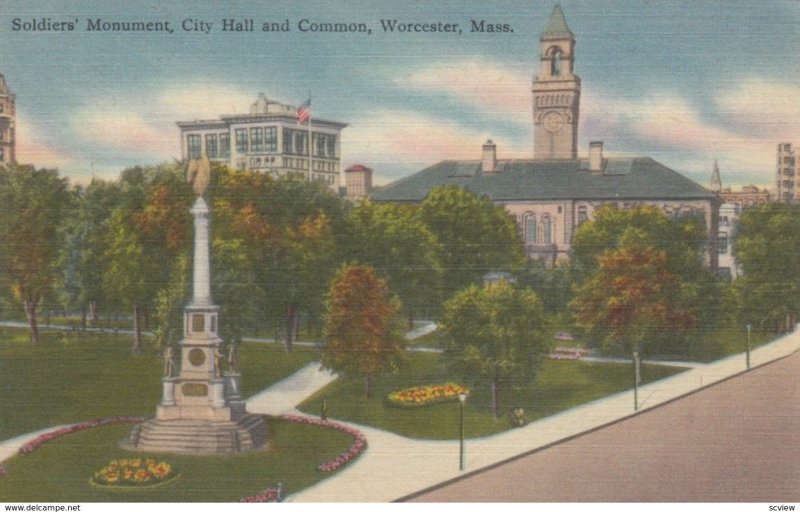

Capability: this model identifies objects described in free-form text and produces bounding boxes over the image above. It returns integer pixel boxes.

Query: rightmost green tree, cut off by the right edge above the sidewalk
[733,203,800,331]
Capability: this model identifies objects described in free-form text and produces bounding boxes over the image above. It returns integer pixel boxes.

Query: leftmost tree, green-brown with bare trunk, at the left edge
[0,165,72,343]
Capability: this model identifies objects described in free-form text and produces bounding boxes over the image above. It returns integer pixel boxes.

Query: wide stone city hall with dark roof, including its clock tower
[372,6,721,270]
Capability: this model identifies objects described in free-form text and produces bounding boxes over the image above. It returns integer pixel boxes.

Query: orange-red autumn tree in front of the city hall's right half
[571,227,695,351]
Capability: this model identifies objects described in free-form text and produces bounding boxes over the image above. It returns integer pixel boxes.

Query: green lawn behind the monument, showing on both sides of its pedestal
[0,328,316,440]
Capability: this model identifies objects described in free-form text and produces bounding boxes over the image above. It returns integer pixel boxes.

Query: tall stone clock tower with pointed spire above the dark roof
[532,4,581,160]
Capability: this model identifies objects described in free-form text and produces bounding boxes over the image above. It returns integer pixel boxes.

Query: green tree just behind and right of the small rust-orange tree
[346,200,442,327]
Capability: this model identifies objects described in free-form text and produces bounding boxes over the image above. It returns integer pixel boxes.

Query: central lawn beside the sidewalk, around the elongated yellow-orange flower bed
[300,353,681,439]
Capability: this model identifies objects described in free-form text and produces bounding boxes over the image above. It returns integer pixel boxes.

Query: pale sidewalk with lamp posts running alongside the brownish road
[282,331,800,502]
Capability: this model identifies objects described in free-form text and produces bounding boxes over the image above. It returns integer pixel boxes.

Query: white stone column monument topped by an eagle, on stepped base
[124,158,267,454]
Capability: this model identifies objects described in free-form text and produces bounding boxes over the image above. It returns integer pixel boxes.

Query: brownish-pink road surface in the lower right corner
[410,340,800,502]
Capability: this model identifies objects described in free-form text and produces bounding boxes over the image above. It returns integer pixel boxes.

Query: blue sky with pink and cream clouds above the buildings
[0,0,800,188]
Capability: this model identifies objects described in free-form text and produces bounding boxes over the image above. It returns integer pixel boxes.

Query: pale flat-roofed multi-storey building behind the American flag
[177,94,347,192]
